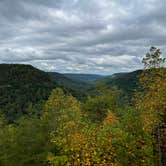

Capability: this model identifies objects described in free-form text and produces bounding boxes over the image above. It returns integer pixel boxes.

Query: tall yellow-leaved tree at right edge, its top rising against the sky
[136,47,166,133]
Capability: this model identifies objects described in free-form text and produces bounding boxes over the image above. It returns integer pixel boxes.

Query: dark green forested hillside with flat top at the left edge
[0,64,57,122]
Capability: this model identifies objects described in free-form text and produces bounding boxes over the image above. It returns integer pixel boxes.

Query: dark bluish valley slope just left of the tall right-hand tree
[100,70,142,95]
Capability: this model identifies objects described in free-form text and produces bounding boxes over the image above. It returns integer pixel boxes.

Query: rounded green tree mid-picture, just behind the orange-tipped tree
[82,86,120,123]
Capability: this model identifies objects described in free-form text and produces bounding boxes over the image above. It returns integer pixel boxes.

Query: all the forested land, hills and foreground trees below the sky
[0,47,166,166]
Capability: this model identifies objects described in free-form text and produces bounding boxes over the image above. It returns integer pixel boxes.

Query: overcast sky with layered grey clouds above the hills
[0,0,166,75]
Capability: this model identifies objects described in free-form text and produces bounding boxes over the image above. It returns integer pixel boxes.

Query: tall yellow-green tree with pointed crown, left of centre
[42,88,83,166]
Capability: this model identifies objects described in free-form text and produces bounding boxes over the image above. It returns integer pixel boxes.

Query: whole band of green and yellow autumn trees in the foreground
[0,47,166,166]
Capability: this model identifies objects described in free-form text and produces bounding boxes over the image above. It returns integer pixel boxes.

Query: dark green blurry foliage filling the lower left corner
[0,118,51,166]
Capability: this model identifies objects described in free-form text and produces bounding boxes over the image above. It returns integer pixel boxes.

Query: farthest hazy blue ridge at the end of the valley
[64,73,104,83]
